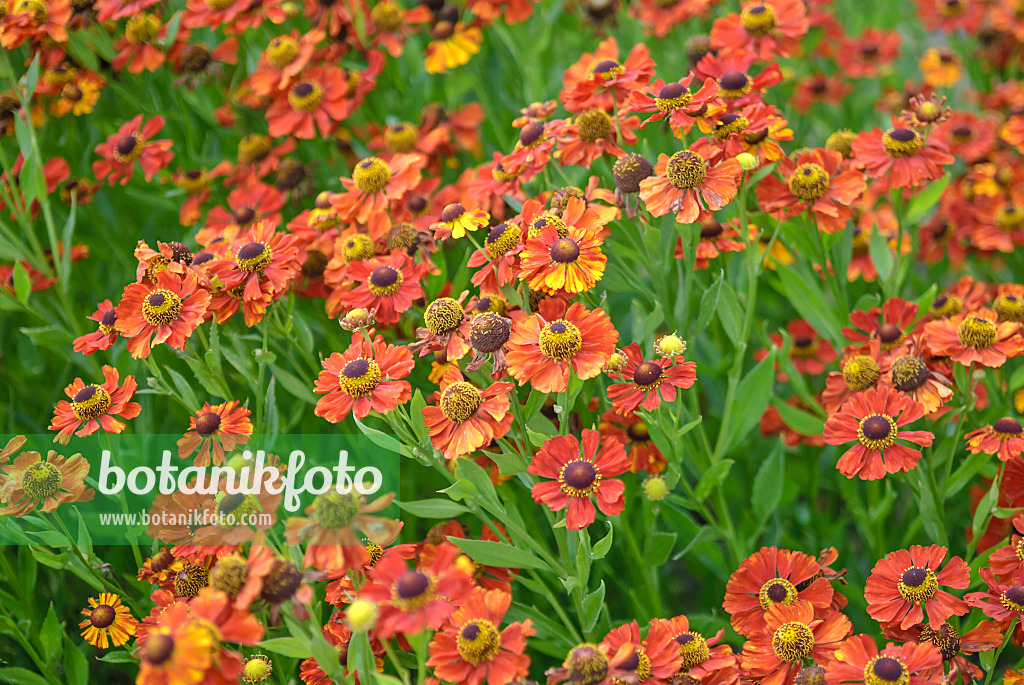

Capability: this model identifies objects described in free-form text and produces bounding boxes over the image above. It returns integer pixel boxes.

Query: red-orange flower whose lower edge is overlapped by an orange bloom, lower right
[722,547,834,638]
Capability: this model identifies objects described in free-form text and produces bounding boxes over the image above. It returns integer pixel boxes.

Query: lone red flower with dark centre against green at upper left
[92,115,174,185]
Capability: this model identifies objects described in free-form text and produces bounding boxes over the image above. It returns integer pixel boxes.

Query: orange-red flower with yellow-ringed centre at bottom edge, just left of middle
[427,589,536,685]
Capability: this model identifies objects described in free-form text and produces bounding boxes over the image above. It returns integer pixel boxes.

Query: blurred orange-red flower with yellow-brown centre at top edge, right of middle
[711,0,810,61]
